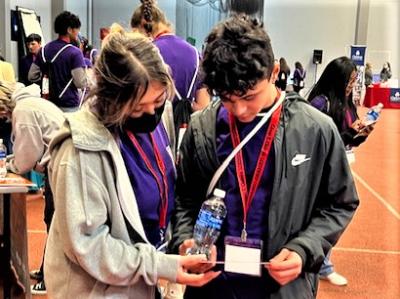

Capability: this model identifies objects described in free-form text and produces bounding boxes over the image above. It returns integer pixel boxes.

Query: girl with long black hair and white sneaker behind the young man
[308,56,373,286]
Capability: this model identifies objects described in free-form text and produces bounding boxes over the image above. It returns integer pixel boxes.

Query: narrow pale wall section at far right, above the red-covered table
[366,0,400,83]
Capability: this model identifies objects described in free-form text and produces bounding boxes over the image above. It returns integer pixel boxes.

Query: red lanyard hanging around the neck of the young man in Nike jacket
[229,105,282,239]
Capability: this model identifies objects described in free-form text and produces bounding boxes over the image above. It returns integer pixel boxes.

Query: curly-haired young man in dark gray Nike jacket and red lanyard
[170,15,359,299]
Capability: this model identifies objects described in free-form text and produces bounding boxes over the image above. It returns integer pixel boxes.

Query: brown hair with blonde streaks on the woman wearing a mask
[89,32,174,127]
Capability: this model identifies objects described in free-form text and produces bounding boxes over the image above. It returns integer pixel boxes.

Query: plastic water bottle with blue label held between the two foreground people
[189,189,226,257]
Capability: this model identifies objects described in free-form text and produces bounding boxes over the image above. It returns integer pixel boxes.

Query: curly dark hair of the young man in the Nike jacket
[201,14,274,96]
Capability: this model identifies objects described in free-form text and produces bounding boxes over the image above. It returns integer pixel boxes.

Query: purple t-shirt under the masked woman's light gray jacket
[121,123,176,245]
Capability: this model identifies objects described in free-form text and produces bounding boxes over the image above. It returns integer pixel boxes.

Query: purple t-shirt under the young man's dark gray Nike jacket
[197,106,275,299]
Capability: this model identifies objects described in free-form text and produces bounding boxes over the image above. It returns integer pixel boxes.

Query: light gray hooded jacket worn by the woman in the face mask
[44,105,179,299]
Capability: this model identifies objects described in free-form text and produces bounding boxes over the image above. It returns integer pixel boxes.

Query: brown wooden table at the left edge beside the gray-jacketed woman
[0,174,31,299]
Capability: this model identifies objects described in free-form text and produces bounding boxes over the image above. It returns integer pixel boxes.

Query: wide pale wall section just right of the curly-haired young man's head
[264,0,357,92]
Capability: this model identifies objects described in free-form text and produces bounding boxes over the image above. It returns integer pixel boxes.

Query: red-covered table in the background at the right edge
[364,85,400,109]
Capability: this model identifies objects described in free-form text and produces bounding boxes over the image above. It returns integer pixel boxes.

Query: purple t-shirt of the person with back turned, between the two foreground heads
[154,34,201,99]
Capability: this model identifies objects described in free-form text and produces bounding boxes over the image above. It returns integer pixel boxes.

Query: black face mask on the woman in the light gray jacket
[122,102,165,133]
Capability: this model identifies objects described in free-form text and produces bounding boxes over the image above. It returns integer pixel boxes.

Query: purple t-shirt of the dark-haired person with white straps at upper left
[34,39,85,108]
